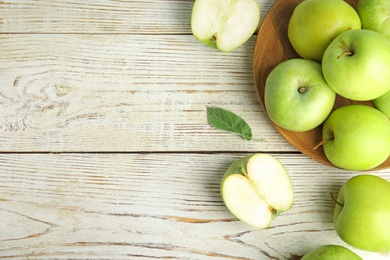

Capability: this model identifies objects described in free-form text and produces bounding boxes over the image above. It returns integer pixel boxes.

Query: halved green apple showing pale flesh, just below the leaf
[221,153,294,229]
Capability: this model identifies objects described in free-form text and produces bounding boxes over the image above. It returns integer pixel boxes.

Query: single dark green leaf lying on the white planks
[207,107,252,141]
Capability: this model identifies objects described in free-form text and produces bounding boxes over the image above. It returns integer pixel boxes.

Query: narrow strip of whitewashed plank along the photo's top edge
[0,0,274,34]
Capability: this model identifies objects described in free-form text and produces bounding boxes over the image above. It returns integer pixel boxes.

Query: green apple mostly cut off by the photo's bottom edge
[301,245,363,260]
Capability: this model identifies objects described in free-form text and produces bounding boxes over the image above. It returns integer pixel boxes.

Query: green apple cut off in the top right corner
[357,0,390,40]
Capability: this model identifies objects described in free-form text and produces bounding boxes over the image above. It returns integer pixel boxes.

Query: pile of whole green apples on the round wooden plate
[264,0,390,170]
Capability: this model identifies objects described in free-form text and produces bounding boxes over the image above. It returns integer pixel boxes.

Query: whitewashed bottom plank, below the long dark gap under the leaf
[0,153,390,260]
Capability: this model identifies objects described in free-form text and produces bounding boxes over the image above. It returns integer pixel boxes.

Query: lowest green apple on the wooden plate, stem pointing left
[322,105,390,170]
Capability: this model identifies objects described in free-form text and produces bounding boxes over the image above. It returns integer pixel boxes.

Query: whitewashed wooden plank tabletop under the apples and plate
[0,0,390,259]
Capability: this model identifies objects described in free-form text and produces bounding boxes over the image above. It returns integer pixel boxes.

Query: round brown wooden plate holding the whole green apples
[253,0,390,170]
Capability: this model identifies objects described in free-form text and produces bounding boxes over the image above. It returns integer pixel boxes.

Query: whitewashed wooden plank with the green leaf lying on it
[0,35,295,152]
